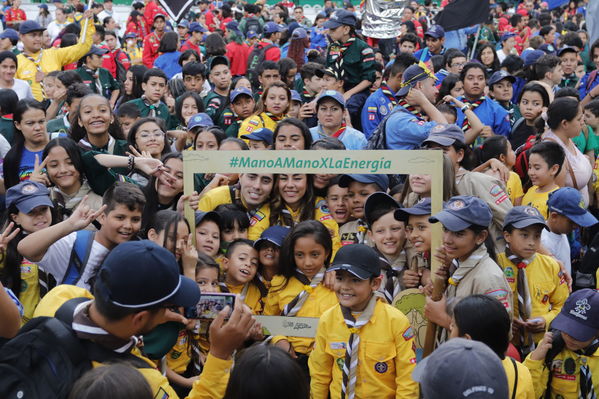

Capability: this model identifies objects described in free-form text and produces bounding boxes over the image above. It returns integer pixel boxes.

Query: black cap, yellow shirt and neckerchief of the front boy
[309,244,418,399]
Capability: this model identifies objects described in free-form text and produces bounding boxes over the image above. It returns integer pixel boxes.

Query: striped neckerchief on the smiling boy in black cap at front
[339,295,376,399]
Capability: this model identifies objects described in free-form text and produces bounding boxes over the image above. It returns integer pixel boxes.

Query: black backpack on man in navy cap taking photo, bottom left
[0,298,152,399]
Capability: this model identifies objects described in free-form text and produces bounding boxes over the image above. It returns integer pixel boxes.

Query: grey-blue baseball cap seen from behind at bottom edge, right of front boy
[412,338,508,399]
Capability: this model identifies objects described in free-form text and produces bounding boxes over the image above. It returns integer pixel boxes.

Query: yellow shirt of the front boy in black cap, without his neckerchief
[308,301,418,399]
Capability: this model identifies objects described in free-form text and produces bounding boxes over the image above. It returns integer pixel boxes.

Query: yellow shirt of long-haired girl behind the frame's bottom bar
[264,276,338,354]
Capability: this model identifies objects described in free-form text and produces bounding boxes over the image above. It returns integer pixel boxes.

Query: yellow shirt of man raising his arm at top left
[15,20,96,101]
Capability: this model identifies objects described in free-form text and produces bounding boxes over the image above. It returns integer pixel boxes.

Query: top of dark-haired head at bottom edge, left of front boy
[223,344,310,399]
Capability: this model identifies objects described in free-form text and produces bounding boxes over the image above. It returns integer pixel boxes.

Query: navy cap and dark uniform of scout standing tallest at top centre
[324,10,375,91]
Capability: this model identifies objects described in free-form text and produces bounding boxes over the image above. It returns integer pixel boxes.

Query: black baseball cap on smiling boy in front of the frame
[329,244,381,280]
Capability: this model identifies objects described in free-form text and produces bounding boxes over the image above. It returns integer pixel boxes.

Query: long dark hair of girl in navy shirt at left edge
[4,99,46,190]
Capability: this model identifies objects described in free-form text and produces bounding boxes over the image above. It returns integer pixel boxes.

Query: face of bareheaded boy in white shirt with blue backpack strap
[98,204,141,246]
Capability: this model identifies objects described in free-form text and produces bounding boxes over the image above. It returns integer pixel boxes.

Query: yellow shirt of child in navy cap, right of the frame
[497,253,570,342]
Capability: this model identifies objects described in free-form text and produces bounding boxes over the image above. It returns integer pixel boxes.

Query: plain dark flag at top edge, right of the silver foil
[435,0,489,32]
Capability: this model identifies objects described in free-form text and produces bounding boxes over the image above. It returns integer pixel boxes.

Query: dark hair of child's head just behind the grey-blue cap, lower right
[453,294,511,359]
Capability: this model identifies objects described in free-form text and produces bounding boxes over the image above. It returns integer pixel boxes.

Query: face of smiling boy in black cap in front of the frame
[335,270,381,312]
